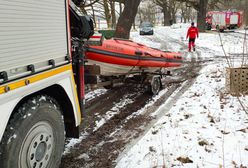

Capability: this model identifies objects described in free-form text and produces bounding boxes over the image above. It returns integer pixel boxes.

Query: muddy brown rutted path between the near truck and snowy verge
[60,34,207,168]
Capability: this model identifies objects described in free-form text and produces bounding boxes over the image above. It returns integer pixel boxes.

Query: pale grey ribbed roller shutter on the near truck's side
[0,0,69,84]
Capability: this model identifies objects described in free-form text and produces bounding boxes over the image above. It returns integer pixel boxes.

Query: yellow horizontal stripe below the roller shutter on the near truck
[0,64,72,94]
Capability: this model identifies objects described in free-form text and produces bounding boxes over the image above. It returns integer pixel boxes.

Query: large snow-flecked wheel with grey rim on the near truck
[0,95,65,168]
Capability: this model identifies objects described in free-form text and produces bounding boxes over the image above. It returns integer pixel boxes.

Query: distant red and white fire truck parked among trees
[206,10,243,32]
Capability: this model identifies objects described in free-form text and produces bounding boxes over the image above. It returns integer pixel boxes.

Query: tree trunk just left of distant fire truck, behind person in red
[197,0,208,32]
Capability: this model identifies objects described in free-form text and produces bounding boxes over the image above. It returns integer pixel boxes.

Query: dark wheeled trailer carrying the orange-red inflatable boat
[84,65,171,95]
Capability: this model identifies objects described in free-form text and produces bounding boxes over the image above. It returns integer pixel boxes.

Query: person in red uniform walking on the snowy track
[186,22,199,52]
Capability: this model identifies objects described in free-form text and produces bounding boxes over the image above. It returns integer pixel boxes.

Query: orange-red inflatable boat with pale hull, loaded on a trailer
[85,39,182,76]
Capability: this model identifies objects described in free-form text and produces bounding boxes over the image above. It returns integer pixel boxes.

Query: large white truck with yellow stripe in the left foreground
[0,0,93,168]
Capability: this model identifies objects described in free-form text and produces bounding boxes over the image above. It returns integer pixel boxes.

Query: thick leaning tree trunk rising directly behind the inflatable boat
[114,0,141,39]
